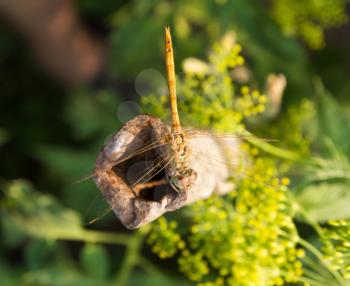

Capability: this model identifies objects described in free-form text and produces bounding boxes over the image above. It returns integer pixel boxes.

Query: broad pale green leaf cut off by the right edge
[296,138,350,222]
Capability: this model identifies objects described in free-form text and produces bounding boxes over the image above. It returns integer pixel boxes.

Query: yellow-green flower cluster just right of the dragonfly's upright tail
[179,41,266,132]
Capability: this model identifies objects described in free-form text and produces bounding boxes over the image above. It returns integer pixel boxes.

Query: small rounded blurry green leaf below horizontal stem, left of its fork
[80,244,109,278]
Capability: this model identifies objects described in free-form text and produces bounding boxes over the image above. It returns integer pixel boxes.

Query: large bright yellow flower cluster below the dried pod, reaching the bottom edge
[174,158,304,286]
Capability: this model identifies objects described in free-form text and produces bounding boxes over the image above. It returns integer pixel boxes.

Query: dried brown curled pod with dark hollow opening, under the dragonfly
[94,115,239,229]
